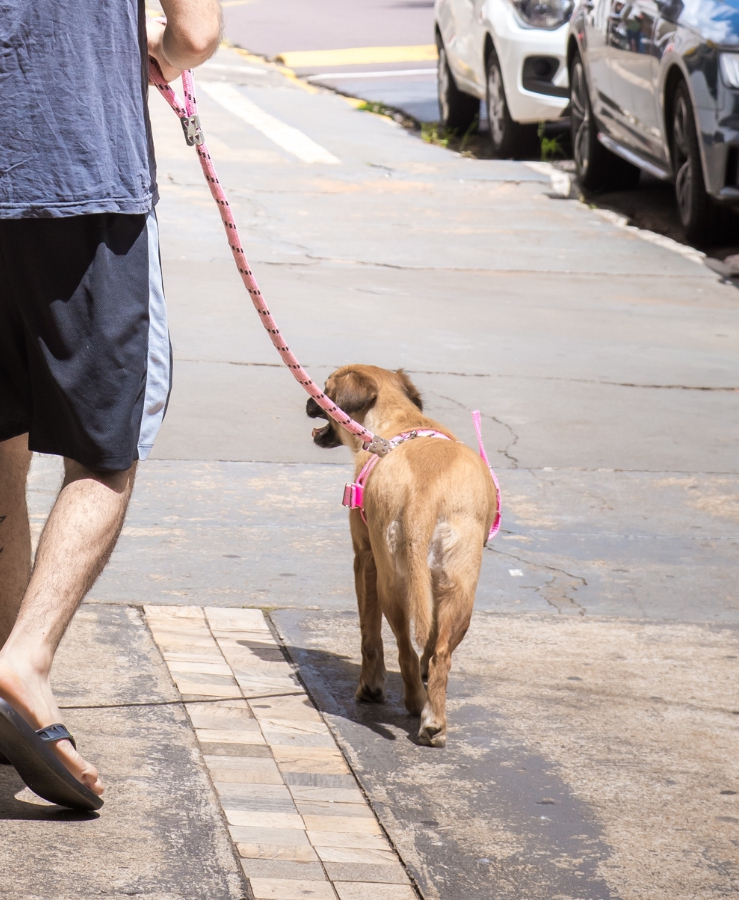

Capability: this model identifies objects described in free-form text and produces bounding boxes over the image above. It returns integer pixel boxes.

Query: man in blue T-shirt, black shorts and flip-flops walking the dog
[0,0,221,796]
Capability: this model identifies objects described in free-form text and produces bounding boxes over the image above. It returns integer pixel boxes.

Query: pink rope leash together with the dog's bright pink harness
[149,60,501,540]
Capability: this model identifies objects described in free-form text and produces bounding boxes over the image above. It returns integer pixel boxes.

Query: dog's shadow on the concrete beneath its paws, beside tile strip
[285,644,419,744]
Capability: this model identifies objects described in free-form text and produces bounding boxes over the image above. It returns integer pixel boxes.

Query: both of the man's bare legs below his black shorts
[0,435,136,794]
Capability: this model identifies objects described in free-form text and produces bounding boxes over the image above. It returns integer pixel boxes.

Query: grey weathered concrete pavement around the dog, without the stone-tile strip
[0,45,739,900]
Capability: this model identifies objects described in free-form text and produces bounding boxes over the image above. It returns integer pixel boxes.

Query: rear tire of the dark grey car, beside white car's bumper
[570,53,641,191]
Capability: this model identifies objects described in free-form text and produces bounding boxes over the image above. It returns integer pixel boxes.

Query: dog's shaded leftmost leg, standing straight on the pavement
[354,550,385,703]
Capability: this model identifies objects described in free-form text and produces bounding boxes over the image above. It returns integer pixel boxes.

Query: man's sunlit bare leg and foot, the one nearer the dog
[0,460,136,794]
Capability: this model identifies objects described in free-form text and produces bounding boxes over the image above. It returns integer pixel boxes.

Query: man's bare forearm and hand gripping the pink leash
[146,0,221,81]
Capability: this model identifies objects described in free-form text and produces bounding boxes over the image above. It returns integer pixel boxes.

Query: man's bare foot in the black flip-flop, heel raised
[0,658,105,796]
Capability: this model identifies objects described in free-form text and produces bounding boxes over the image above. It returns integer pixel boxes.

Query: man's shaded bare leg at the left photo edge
[0,434,31,647]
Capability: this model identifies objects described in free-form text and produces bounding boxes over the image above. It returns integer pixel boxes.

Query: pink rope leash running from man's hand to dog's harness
[149,59,392,457]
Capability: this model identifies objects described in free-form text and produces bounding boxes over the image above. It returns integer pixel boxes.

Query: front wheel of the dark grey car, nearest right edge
[672,82,718,244]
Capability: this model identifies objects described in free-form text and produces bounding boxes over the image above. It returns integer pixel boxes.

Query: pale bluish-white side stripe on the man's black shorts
[138,209,172,459]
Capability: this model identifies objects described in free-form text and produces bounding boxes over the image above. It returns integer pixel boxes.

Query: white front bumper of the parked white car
[490,2,569,123]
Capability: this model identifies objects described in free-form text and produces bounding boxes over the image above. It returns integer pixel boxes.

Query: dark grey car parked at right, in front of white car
[567,0,739,243]
